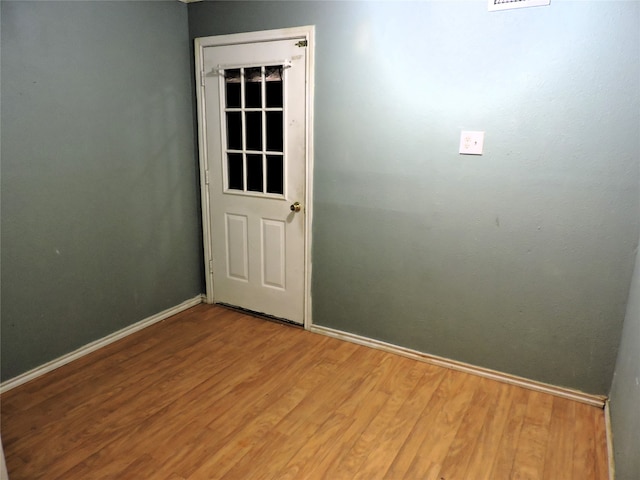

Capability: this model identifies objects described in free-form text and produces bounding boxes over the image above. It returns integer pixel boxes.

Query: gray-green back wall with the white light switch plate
[189,1,640,394]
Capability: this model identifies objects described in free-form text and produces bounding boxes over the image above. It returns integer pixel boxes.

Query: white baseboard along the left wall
[0,295,203,394]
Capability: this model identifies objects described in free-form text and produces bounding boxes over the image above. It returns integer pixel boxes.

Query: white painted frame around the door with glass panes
[194,25,315,330]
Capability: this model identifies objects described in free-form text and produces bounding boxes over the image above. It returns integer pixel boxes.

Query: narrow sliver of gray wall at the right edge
[610,248,640,480]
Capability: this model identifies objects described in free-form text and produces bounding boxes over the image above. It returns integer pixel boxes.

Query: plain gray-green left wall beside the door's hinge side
[1,0,202,380]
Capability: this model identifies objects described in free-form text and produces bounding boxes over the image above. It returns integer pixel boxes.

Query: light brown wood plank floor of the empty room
[0,305,607,480]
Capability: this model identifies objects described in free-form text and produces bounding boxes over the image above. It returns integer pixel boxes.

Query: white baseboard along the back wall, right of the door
[309,325,606,408]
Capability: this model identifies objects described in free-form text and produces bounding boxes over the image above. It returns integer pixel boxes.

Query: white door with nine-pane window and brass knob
[199,31,308,324]
